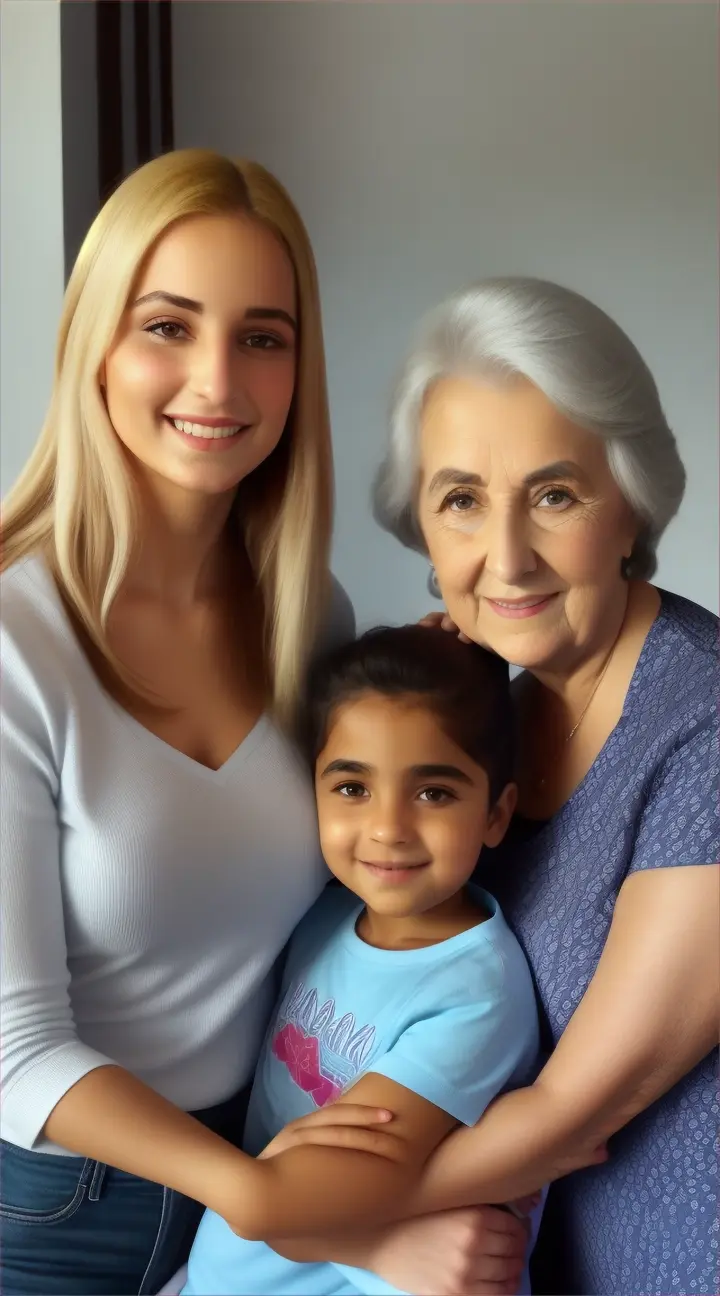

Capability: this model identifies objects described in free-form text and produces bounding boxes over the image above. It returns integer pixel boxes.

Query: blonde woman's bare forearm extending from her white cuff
[44,1067,255,1217]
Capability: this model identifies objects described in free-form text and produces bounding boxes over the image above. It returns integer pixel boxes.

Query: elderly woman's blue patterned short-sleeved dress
[482,594,720,1296]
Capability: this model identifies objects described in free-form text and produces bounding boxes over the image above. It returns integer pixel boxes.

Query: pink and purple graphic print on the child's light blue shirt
[272,982,376,1107]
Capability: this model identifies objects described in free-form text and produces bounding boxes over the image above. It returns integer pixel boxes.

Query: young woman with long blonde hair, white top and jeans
[0,152,352,1296]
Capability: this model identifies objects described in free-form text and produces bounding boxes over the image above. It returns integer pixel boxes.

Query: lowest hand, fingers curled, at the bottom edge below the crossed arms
[372,1207,528,1296]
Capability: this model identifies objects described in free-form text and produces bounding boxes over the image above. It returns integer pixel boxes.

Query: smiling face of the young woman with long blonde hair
[101,215,297,495]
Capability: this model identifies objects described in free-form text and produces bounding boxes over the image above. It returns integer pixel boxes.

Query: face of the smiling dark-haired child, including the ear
[315,693,515,918]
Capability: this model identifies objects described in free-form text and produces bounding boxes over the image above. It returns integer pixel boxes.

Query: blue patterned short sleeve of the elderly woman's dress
[628,718,720,874]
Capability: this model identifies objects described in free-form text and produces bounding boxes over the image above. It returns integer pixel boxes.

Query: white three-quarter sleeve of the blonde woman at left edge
[0,635,110,1148]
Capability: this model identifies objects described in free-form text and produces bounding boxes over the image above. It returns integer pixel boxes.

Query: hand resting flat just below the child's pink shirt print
[259,1103,400,1161]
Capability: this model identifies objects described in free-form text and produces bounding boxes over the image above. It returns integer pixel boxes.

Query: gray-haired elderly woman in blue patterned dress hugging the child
[365,279,720,1296]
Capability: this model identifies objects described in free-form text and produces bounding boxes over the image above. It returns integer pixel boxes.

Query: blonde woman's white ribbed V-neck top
[0,557,354,1153]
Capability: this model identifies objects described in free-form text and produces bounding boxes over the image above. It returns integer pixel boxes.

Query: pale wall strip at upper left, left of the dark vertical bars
[0,0,63,492]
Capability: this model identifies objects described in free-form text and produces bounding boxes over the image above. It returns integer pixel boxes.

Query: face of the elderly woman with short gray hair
[418,378,637,670]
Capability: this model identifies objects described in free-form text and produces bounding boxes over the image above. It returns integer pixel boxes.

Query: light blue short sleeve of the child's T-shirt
[369,990,537,1125]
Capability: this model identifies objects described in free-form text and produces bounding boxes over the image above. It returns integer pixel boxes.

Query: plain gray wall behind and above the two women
[174,0,719,623]
